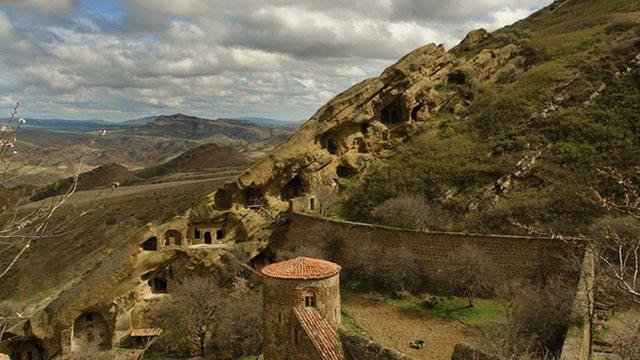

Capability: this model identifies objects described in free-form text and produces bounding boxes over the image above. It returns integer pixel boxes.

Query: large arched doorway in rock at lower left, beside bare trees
[71,312,111,353]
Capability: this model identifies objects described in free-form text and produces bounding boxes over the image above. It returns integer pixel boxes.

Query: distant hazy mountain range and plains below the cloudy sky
[6,114,295,186]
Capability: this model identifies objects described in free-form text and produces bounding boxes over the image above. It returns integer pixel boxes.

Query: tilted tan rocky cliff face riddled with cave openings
[190,30,527,253]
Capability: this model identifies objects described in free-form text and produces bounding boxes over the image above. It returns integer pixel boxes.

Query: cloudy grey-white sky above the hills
[0,0,551,121]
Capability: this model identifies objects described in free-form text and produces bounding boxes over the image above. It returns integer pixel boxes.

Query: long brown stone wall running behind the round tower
[264,213,576,286]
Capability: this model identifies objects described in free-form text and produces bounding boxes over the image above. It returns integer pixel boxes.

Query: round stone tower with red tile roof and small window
[262,257,343,360]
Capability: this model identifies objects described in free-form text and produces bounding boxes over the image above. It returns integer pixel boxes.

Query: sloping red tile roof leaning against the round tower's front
[293,307,344,360]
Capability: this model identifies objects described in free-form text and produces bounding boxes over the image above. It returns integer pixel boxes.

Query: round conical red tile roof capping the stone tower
[262,257,341,280]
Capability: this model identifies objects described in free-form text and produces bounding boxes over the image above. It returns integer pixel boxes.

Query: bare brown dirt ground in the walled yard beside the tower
[342,297,487,360]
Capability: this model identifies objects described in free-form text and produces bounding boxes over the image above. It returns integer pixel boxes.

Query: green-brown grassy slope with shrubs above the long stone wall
[342,0,640,232]
